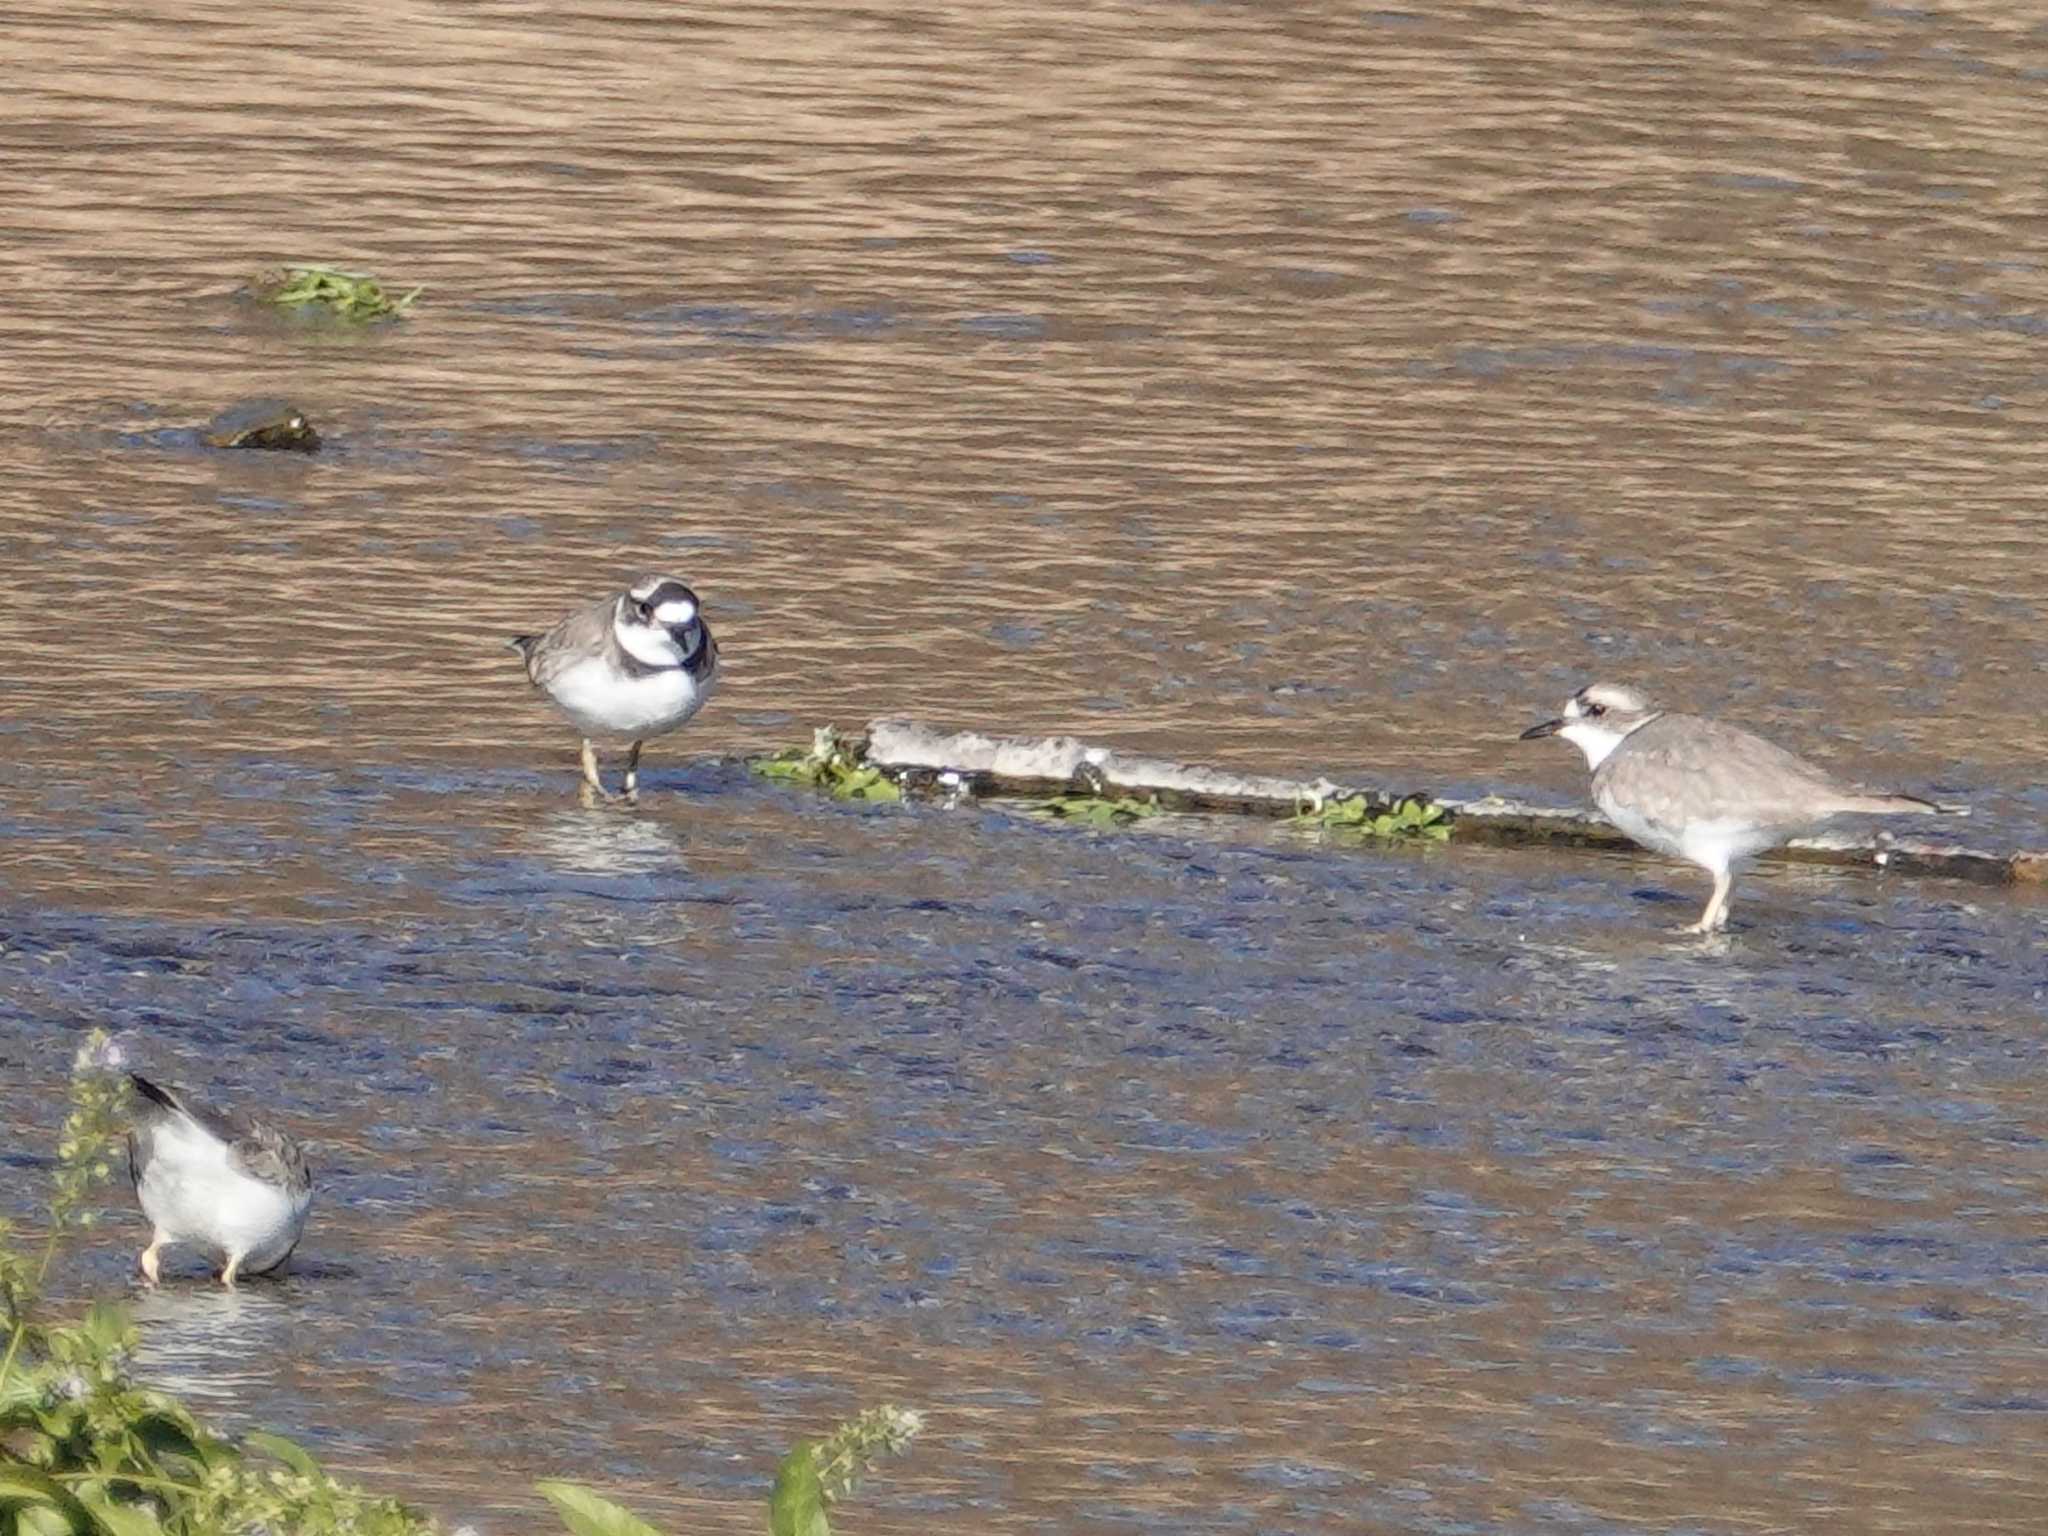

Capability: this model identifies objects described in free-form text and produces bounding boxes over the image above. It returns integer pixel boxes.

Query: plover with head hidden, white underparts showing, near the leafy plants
[129,1073,313,1288]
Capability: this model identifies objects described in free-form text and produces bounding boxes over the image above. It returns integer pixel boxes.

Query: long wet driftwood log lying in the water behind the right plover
[866,719,2048,885]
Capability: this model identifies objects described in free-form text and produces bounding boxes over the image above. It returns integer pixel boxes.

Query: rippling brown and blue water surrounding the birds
[0,0,2048,1536]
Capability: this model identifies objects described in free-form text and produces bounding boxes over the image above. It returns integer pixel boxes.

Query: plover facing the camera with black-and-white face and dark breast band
[512,575,719,801]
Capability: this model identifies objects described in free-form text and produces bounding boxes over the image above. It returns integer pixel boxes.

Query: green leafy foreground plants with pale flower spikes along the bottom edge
[0,1030,924,1536]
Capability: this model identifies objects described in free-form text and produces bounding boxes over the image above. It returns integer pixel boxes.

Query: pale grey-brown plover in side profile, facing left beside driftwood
[1522,682,1968,934]
